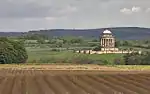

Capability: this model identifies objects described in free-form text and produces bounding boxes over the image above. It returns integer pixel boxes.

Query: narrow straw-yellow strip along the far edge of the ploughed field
[0,64,150,71]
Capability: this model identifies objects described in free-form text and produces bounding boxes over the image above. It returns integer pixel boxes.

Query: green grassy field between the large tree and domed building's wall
[27,48,123,64]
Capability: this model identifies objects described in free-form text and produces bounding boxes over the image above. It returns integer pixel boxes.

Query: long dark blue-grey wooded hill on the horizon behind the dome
[0,27,150,40]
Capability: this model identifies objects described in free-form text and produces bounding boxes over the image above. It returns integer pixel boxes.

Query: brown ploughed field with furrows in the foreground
[0,68,150,94]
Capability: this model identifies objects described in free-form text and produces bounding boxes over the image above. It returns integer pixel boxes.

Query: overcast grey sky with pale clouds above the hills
[0,0,150,31]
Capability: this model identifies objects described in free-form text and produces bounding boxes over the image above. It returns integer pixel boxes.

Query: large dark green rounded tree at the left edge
[0,38,28,64]
